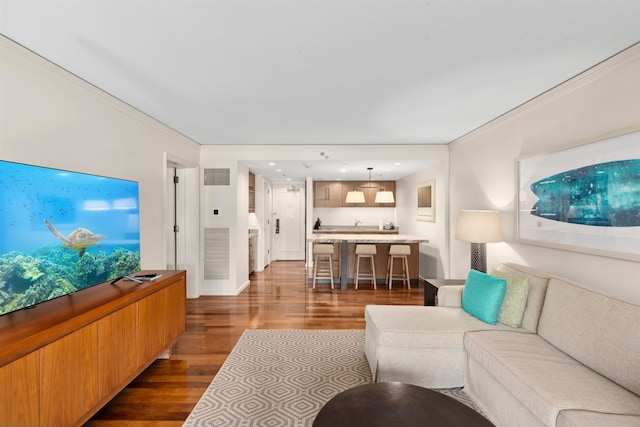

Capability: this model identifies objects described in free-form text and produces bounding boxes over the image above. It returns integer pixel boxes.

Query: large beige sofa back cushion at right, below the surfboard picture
[538,278,640,395]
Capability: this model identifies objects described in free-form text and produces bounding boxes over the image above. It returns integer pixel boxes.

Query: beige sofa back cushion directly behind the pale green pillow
[498,263,552,333]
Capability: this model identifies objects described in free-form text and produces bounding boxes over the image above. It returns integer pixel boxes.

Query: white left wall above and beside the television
[0,36,200,294]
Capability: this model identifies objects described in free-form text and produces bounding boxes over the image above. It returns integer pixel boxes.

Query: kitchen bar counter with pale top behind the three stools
[309,233,429,290]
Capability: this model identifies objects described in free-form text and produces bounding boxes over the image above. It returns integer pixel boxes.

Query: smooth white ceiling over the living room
[0,0,640,179]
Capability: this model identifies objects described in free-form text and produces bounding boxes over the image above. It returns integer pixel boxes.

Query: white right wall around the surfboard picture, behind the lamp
[450,45,640,302]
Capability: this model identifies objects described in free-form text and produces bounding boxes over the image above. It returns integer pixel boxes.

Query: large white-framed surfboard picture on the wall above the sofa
[516,129,640,262]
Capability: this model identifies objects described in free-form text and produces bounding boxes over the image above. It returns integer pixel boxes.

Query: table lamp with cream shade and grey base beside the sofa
[456,210,502,273]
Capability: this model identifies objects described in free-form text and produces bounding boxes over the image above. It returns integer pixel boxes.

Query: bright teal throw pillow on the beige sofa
[462,270,507,325]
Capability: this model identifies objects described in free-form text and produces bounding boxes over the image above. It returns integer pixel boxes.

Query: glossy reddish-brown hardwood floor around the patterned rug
[85,261,423,427]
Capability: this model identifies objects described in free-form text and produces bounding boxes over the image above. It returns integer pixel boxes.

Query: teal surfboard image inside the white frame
[530,159,640,227]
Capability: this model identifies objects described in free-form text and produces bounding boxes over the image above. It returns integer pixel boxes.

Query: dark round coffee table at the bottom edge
[313,382,493,427]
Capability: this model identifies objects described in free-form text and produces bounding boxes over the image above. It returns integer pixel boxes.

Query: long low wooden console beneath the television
[0,270,186,426]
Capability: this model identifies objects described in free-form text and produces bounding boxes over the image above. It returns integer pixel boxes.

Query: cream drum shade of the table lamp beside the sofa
[456,210,502,243]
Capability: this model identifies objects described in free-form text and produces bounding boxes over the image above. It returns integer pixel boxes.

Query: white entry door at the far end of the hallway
[272,184,305,260]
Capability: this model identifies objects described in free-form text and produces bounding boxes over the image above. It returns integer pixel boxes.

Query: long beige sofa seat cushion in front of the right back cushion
[464,330,640,426]
